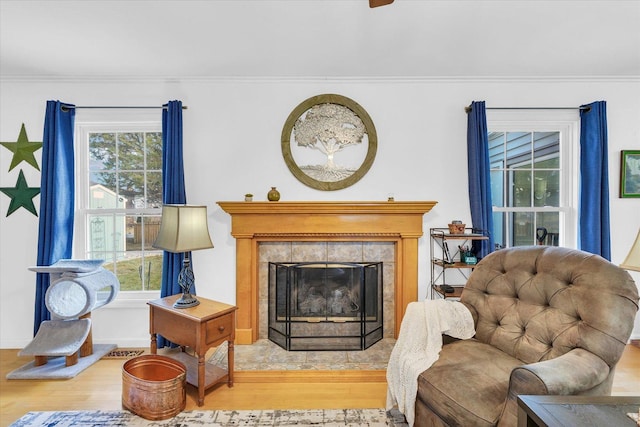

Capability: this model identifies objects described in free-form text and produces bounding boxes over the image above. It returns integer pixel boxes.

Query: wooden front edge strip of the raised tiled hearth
[233,370,387,383]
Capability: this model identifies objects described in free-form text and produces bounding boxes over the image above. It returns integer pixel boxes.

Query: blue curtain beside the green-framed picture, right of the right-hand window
[578,101,611,261]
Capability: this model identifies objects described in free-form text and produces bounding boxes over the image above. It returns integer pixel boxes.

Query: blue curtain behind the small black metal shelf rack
[467,101,493,259]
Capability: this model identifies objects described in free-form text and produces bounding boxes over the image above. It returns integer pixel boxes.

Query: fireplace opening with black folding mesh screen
[268,262,383,351]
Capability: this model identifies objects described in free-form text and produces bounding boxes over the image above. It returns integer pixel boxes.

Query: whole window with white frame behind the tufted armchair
[487,112,578,248]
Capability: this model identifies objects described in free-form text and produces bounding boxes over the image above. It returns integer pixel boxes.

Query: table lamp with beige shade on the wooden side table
[153,205,213,308]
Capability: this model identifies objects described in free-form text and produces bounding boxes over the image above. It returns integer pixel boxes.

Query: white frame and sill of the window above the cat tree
[73,118,162,302]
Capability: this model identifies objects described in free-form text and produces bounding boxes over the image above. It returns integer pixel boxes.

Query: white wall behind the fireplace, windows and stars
[0,79,640,348]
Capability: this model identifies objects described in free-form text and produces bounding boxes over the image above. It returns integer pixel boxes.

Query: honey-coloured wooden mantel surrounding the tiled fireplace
[218,201,437,344]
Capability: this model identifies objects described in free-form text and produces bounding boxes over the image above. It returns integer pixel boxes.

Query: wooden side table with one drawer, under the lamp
[148,295,237,406]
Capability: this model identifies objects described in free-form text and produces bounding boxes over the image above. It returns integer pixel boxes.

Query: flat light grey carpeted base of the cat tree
[7,344,116,380]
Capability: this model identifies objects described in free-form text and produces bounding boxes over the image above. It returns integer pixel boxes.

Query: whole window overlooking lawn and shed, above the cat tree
[76,123,162,292]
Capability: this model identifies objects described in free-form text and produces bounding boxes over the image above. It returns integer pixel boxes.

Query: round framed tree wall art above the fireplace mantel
[282,94,378,191]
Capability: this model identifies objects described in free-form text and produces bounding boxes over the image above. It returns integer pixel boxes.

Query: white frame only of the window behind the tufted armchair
[487,109,580,248]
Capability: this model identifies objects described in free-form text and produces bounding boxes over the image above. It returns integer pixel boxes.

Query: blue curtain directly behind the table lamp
[158,101,188,348]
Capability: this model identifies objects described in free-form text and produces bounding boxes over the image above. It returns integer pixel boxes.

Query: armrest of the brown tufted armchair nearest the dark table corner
[509,348,611,395]
